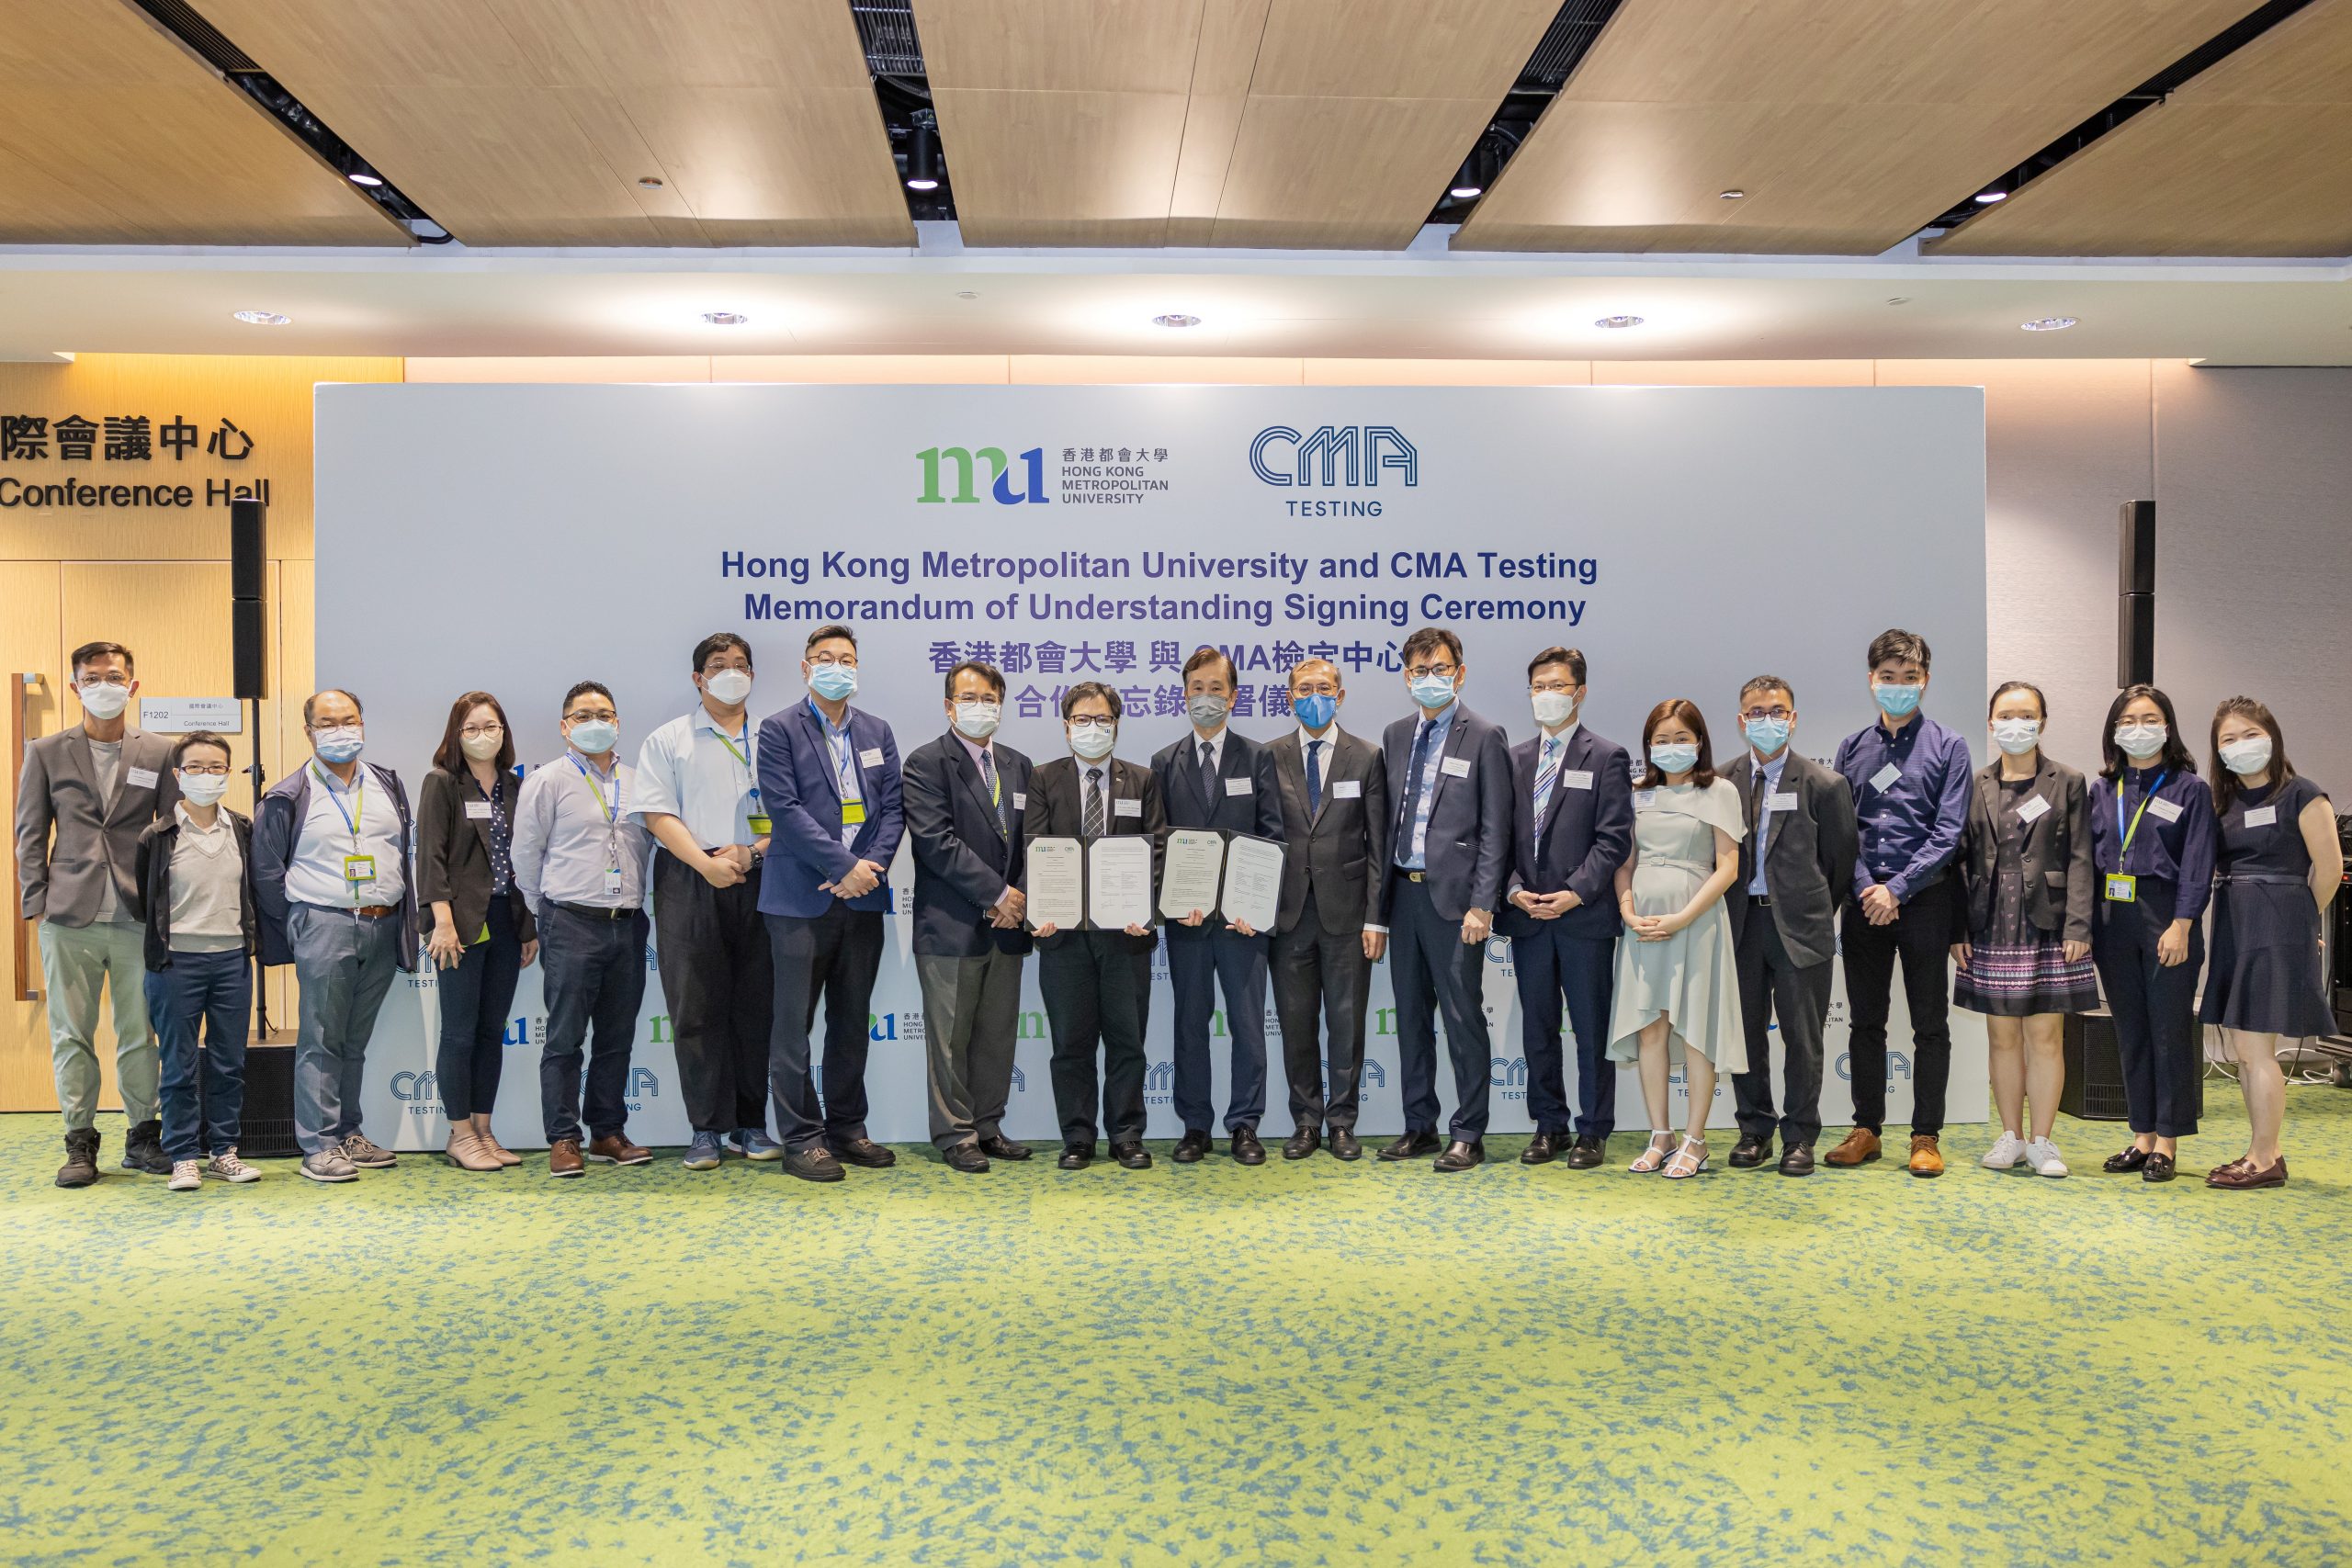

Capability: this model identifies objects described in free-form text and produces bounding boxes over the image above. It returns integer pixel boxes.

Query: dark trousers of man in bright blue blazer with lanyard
[767,898,882,1149]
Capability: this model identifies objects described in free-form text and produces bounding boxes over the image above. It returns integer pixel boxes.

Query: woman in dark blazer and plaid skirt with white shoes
[1952,682,2098,1176]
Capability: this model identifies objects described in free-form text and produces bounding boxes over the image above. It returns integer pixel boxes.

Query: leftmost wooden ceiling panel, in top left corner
[0,0,409,244]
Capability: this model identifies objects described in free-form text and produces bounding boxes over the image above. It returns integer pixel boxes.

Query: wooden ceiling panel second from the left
[198,0,915,244]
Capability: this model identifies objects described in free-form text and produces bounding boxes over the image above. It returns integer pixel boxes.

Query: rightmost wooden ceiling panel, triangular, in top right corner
[1931,0,2352,256]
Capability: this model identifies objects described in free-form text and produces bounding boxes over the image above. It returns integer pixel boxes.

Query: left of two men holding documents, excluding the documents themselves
[1021,682,1167,1170]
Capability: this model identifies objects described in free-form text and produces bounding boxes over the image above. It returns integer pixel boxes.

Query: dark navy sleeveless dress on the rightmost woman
[2197,778,2335,1039]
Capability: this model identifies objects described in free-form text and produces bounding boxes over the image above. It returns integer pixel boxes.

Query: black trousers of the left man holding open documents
[1037,931,1150,1147]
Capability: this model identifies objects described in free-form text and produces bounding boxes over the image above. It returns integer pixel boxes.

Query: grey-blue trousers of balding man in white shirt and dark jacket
[287,903,400,1155]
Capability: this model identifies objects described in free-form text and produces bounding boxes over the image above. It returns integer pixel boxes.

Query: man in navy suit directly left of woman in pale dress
[1503,649,1633,1170]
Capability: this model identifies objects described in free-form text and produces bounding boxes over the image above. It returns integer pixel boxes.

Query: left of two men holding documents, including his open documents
[1023,682,1167,1170]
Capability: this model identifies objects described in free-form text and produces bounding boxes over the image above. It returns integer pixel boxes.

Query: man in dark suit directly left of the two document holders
[903,659,1030,1176]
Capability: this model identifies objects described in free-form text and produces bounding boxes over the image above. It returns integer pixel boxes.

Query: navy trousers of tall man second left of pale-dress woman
[1387,874,1494,1140]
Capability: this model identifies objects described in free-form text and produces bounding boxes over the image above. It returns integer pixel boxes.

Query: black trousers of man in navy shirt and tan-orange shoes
[1839,877,1959,1134]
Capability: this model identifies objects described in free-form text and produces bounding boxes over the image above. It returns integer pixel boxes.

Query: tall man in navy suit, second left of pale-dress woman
[1381,626,1510,1170]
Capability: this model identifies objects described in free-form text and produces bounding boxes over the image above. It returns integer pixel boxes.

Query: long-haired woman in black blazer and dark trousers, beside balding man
[416,691,538,1170]
